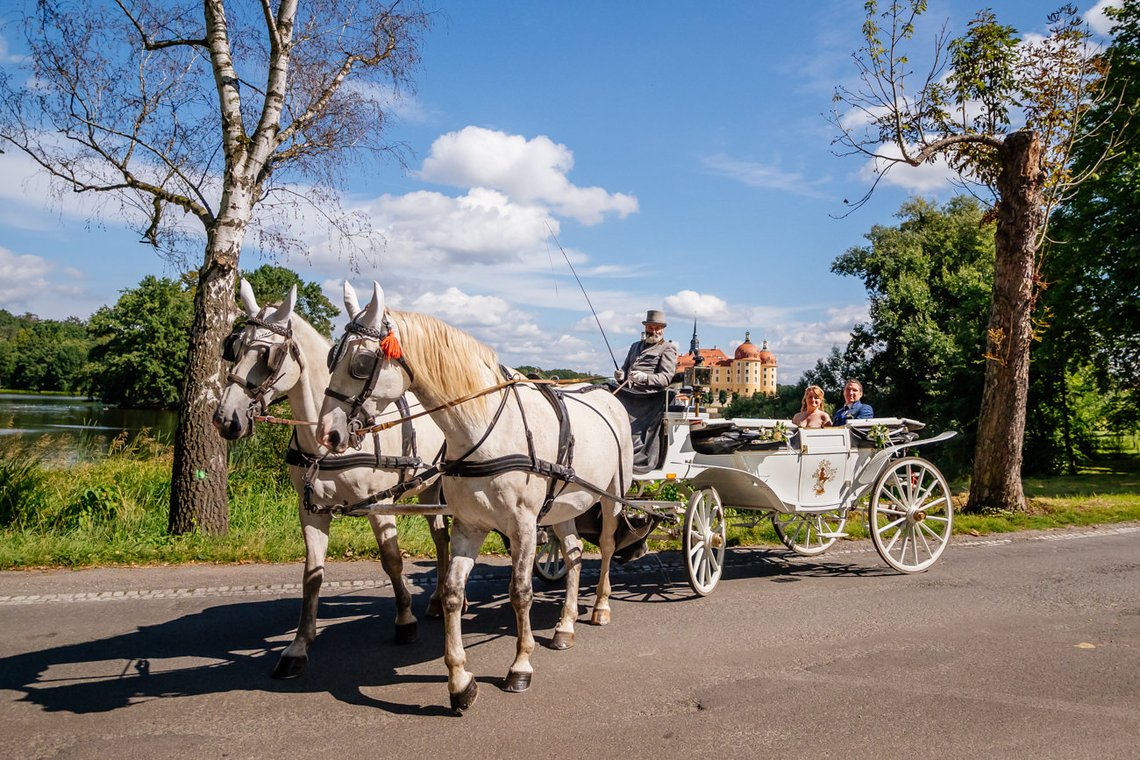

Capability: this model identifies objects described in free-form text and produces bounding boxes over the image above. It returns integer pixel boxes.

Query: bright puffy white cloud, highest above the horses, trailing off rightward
[418,126,637,224]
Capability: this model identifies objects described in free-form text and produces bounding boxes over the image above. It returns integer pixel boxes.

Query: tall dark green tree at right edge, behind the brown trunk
[1026,0,1140,472]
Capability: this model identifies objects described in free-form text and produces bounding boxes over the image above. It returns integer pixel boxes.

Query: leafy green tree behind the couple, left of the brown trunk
[829,196,994,466]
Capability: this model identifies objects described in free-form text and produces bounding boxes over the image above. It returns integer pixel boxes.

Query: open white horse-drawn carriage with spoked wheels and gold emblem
[536,401,955,596]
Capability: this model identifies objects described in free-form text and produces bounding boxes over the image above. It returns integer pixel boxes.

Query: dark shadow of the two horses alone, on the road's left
[0,576,528,716]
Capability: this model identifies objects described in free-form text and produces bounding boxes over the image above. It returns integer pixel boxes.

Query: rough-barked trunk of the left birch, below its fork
[169,224,244,534]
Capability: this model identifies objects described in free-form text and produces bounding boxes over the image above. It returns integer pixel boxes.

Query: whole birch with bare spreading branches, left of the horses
[0,0,429,533]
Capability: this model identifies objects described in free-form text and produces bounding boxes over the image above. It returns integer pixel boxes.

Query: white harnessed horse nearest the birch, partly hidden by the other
[213,279,448,678]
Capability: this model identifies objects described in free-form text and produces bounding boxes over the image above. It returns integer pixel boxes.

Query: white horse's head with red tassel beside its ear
[317,281,412,452]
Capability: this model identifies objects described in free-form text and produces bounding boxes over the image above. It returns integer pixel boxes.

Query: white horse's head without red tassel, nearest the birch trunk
[213,279,302,440]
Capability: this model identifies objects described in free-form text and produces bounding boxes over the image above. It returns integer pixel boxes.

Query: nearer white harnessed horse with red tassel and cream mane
[317,283,633,713]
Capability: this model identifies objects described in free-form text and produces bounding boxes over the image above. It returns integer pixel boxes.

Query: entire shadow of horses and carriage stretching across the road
[0,548,894,716]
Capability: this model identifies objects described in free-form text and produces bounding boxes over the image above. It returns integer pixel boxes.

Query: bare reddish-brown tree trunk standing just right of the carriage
[966,131,1044,512]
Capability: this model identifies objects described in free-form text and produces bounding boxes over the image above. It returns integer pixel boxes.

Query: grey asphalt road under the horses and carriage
[0,523,1140,760]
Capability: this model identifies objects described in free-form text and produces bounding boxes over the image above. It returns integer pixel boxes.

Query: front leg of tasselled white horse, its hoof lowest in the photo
[443,520,487,714]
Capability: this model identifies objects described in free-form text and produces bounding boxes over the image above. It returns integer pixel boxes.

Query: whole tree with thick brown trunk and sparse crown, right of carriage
[832,0,1114,510]
